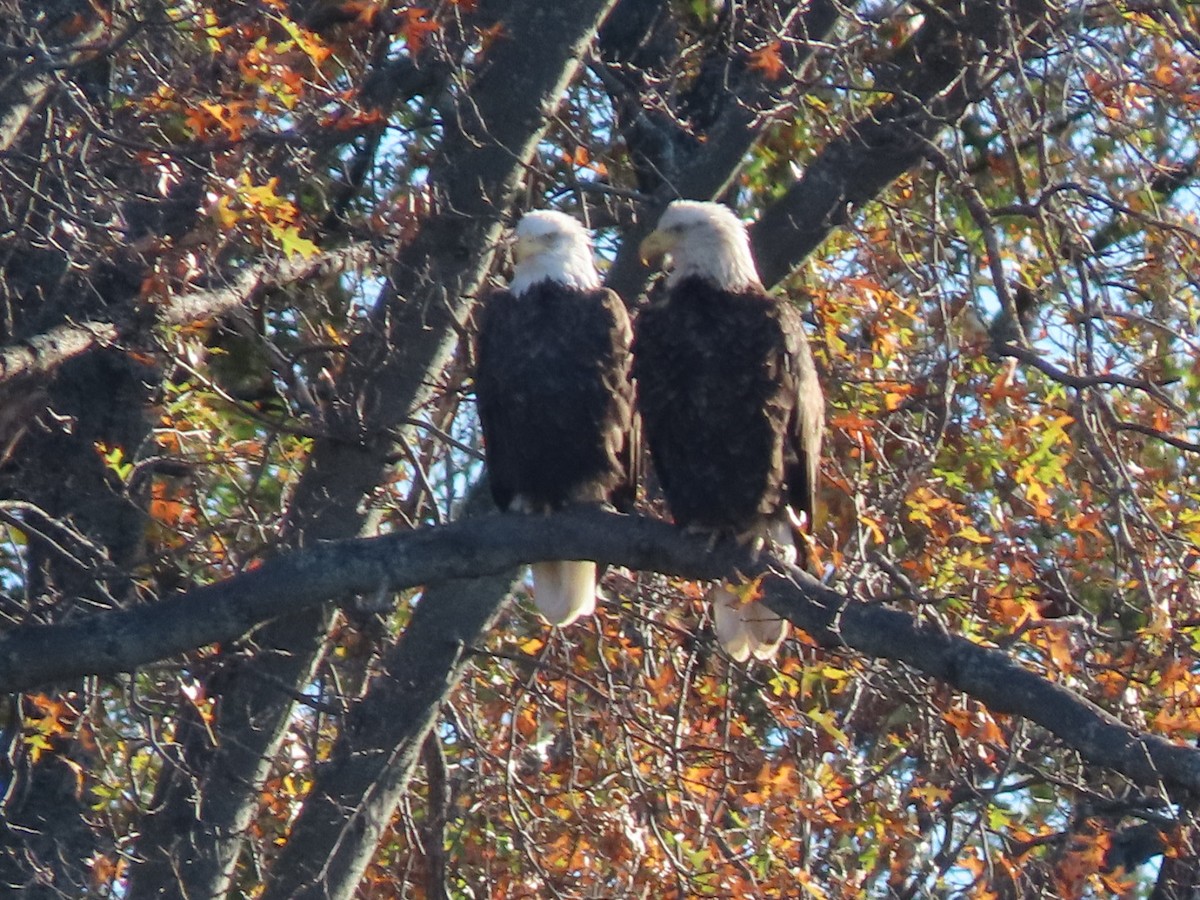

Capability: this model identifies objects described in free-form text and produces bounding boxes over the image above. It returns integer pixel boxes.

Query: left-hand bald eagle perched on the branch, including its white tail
[475,210,632,625]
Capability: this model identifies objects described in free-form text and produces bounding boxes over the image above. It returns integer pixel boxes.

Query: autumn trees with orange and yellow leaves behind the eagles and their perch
[0,0,1200,900]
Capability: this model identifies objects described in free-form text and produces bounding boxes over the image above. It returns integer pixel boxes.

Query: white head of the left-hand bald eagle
[509,209,600,295]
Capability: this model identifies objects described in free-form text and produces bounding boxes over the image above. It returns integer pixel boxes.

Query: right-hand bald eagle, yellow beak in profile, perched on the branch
[634,200,824,660]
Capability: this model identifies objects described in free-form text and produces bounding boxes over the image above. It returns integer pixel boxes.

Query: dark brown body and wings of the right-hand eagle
[634,276,823,549]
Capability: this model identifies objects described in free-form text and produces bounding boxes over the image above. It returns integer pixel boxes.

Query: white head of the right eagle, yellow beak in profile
[640,200,761,290]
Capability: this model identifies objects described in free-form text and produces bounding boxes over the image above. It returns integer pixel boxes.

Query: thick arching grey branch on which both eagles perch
[7,510,1200,791]
